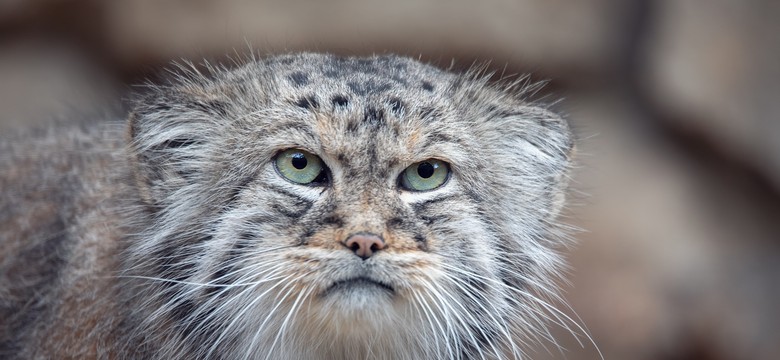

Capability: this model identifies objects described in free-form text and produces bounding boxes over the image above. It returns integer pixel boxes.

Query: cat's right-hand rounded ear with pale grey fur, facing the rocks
[469,98,574,231]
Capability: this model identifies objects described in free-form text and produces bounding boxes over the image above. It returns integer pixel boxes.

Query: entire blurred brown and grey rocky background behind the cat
[0,0,780,360]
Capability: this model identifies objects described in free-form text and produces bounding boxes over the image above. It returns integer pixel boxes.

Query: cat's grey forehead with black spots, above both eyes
[244,54,466,155]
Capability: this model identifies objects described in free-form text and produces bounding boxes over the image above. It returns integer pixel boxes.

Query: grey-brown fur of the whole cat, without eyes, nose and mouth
[0,54,576,359]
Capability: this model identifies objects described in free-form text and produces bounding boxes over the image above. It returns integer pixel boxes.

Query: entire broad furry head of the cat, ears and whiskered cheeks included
[128,54,572,358]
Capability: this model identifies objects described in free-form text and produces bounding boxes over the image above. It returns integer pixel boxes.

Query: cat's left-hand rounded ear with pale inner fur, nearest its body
[128,89,226,206]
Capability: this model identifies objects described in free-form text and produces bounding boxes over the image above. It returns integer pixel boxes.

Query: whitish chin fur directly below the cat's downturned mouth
[224,286,432,360]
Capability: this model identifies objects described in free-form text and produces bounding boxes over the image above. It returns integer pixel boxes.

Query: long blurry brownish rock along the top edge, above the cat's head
[105,0,633,78]
